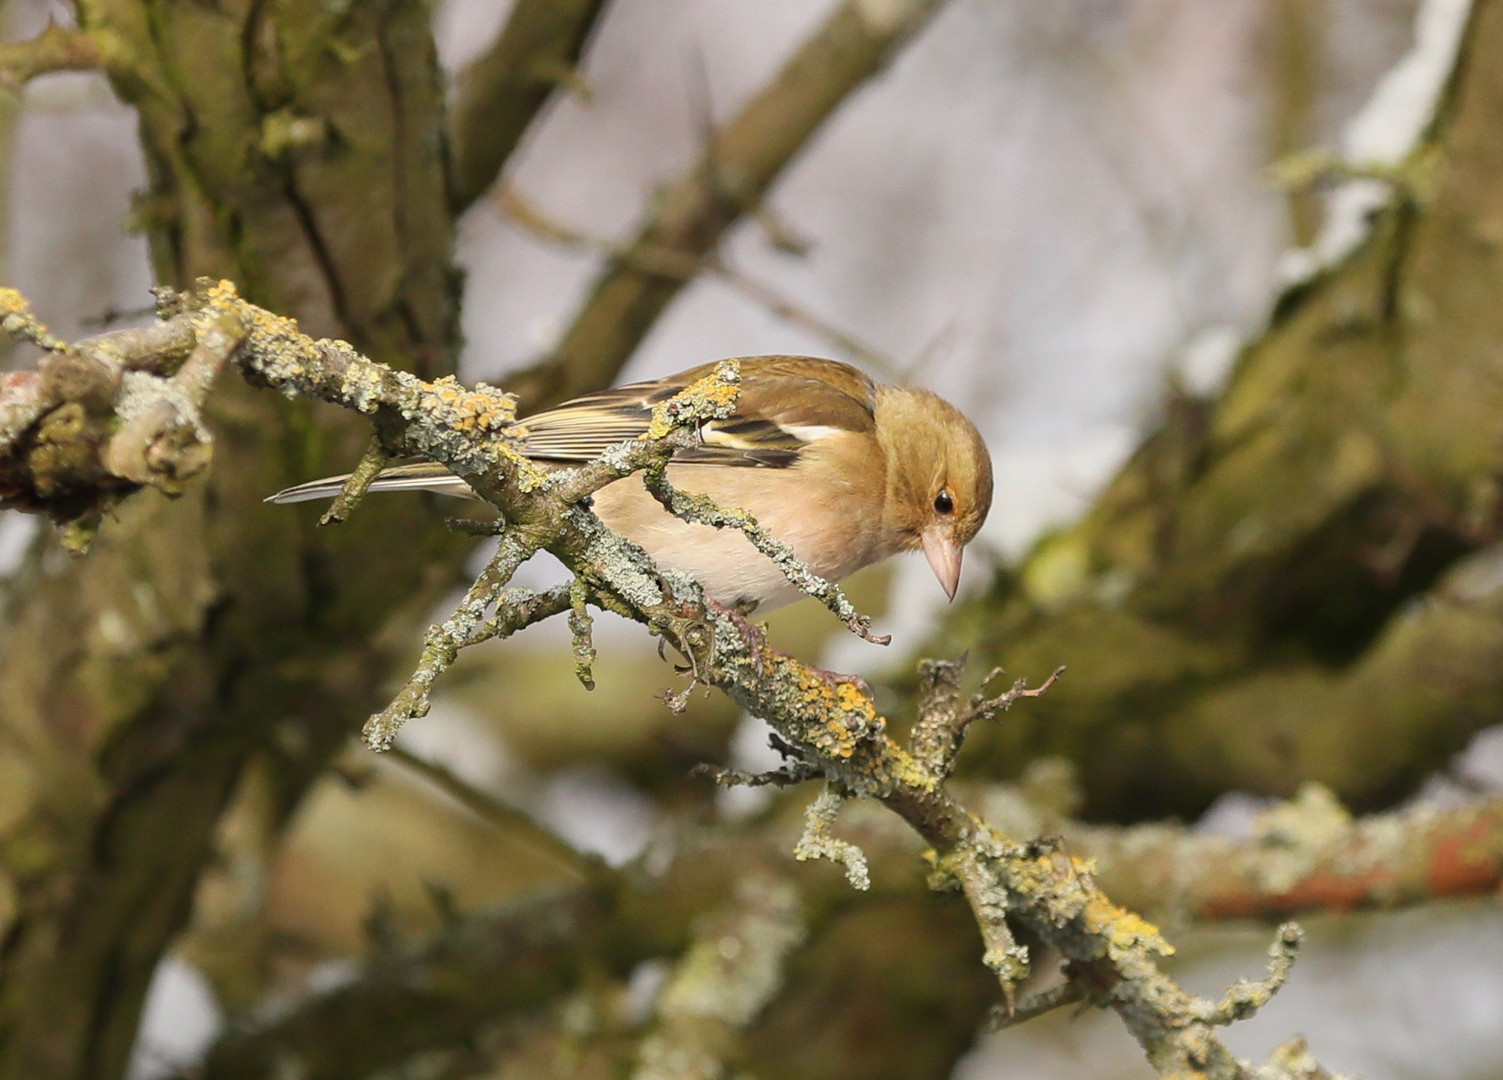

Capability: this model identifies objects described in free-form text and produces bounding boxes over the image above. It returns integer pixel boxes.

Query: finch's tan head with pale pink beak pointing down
[876,386,992,599]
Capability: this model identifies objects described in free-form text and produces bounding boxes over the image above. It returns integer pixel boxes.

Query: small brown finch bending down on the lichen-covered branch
[268,356,992,611]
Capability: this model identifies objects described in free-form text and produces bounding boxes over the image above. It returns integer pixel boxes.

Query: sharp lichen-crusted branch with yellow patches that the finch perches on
[0,282,1328,1080]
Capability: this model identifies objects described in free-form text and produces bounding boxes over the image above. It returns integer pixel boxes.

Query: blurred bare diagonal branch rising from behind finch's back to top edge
[513,0,942,411]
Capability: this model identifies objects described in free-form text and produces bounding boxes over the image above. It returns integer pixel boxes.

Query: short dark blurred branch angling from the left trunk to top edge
[449,0,606,213]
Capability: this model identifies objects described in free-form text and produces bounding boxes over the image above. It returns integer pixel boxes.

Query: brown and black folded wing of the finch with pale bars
[520,356,876,467]
